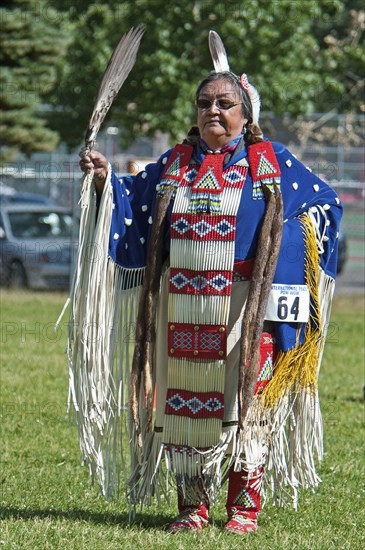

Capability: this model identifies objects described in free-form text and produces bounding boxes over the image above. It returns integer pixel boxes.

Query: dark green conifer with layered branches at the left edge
[0,0,65,161]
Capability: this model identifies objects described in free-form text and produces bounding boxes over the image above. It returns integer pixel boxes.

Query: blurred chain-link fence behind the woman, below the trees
[0,113,365,208]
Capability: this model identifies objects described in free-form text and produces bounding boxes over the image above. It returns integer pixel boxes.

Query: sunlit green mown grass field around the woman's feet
[0,291,365,550]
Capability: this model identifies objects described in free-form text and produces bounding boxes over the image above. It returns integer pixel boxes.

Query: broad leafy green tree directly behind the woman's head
[47,0,356,151]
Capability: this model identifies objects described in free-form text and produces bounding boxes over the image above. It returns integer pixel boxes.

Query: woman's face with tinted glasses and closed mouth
[198,80,247,150]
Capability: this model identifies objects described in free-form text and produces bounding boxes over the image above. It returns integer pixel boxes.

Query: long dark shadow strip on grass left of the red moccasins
[0,507,172,530]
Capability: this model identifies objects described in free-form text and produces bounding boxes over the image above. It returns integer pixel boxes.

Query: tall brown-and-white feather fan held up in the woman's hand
[85,25,144,150]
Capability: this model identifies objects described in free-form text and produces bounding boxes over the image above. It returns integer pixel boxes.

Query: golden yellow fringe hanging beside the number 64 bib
[261,214,322,408]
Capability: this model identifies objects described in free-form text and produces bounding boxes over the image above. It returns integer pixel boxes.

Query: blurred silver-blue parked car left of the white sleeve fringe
[0,201,78,289]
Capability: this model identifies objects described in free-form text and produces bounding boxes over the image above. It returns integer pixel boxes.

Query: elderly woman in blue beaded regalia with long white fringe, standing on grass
[75,44,341,534]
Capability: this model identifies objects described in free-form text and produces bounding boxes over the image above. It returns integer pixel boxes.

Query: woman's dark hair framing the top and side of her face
[195,71,264,145]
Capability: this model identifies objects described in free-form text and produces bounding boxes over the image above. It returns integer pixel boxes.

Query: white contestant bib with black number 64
[265,284,309,323]
